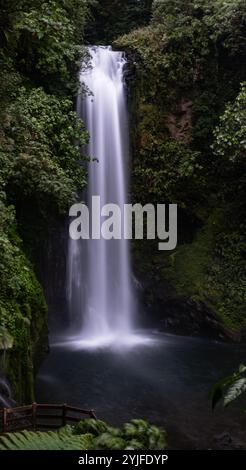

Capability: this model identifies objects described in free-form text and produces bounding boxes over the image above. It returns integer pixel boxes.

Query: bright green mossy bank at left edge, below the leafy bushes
[0,200,47,403]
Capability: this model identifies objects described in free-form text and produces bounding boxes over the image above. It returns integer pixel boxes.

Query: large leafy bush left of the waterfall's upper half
[4,87,88,213]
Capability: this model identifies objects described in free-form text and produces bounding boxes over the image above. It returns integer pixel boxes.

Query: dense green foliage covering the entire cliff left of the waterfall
[0,0,94,401]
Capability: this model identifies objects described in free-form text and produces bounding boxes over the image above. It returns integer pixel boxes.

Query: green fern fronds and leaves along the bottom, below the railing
[0,419,166,450]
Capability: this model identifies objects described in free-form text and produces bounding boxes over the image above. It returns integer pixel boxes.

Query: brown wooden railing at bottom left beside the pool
[0,403,97,433]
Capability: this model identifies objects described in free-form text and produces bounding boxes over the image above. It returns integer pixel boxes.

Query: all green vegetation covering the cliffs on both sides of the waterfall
[0,0,246,408]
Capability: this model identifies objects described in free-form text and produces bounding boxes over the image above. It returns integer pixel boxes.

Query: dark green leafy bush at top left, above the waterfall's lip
[14,0,79,82]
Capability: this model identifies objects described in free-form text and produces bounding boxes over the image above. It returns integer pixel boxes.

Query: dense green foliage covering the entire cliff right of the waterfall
[116,0,246,333]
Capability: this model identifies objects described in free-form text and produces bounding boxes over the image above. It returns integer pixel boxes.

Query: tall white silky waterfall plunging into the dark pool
[68,46,140,344]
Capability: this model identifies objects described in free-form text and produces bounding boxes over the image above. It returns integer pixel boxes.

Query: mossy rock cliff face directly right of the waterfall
[116,46,245,341]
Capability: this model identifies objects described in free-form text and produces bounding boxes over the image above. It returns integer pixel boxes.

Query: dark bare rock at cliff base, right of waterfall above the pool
[135,266,241,342]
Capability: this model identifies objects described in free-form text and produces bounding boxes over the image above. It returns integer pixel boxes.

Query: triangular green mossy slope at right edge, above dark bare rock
[161,210,246,331]
